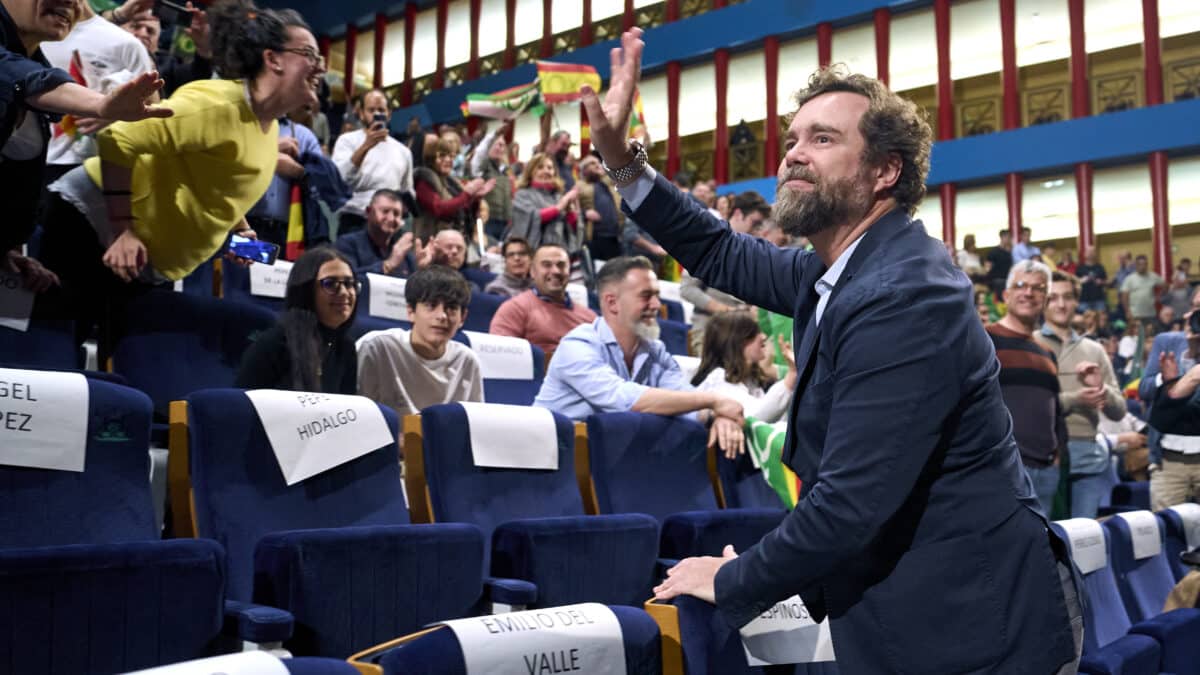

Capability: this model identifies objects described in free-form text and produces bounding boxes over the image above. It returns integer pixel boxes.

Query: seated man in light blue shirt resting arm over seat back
[534,256,744,456]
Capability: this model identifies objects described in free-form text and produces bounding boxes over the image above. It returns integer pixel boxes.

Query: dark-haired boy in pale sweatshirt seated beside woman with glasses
[358,265,484,416]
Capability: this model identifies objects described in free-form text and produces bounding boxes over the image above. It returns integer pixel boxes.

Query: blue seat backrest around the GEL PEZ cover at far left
[0,378,160,549]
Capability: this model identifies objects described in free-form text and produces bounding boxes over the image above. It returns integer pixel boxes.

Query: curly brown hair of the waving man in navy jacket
[787,64,934,215]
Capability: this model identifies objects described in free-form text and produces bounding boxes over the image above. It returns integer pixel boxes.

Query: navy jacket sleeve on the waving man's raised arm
[625,174,820,315]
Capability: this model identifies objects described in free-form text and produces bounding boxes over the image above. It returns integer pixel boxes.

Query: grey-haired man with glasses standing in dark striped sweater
[988,261,1066,518]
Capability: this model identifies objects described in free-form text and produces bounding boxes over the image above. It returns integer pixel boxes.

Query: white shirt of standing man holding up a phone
[334,129,413,215]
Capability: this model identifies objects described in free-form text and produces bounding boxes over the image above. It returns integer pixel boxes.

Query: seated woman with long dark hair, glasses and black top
[234,246,359,394]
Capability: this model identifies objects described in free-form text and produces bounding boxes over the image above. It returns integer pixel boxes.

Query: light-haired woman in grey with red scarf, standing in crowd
[509,154,583,253]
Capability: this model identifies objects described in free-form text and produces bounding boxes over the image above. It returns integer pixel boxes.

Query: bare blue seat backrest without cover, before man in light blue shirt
[588,412,718,514]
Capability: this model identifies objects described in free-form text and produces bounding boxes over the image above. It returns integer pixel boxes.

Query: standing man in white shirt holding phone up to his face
[334,89,413,235]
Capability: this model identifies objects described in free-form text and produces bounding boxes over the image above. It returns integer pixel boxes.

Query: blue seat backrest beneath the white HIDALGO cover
[187,389,408,601]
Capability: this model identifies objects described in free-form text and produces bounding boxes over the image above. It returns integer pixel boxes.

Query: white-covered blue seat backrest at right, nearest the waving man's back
[1050,518,1130,652]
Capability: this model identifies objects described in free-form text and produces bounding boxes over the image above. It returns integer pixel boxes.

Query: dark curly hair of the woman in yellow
[208,0,312,79]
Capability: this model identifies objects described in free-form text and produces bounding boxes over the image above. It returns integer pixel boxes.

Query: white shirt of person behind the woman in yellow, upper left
[42,16,155,165]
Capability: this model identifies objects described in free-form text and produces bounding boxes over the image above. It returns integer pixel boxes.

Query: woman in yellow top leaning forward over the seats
[42,0,325,352]
